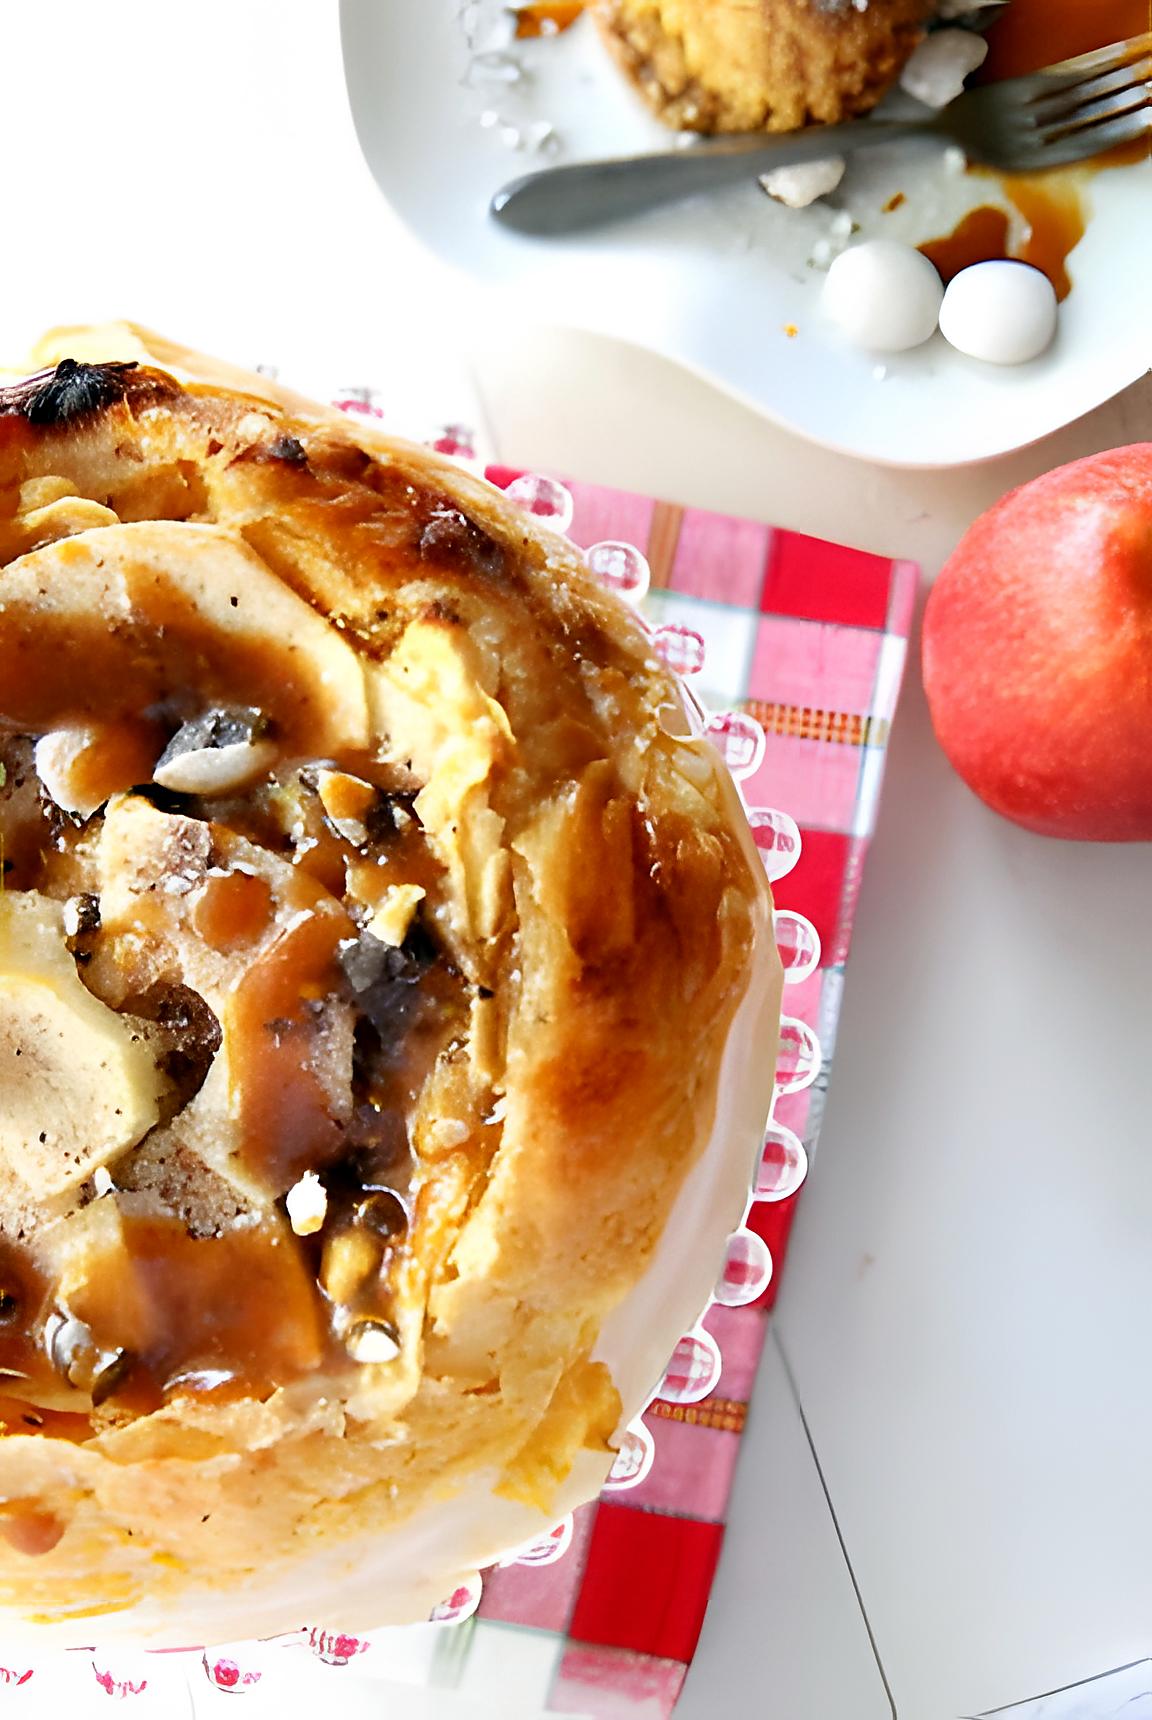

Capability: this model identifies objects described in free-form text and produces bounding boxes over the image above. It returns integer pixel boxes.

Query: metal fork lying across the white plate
[490,31,1152,237]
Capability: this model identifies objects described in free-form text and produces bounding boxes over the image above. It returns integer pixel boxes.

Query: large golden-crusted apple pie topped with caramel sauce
[0,327,779,1639]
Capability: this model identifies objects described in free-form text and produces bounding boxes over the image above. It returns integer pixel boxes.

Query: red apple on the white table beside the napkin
[923,442,1152,843]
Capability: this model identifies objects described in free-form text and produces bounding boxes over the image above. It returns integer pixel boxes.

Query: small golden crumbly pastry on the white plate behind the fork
[593,0,932,132]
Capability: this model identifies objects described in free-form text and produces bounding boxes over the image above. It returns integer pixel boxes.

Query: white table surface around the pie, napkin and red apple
[0,0,1152,1720]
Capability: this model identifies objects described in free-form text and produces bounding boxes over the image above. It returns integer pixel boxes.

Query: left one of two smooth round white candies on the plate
[822,239,944,353]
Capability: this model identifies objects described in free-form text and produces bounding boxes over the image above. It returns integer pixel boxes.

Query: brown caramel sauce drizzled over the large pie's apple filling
[0,447,495,1424]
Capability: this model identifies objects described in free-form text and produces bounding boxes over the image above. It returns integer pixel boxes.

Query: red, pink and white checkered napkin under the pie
[453,466,916,1720]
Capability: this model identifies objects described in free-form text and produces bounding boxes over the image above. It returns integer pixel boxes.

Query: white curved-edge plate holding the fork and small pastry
[340,0,1152,466]
